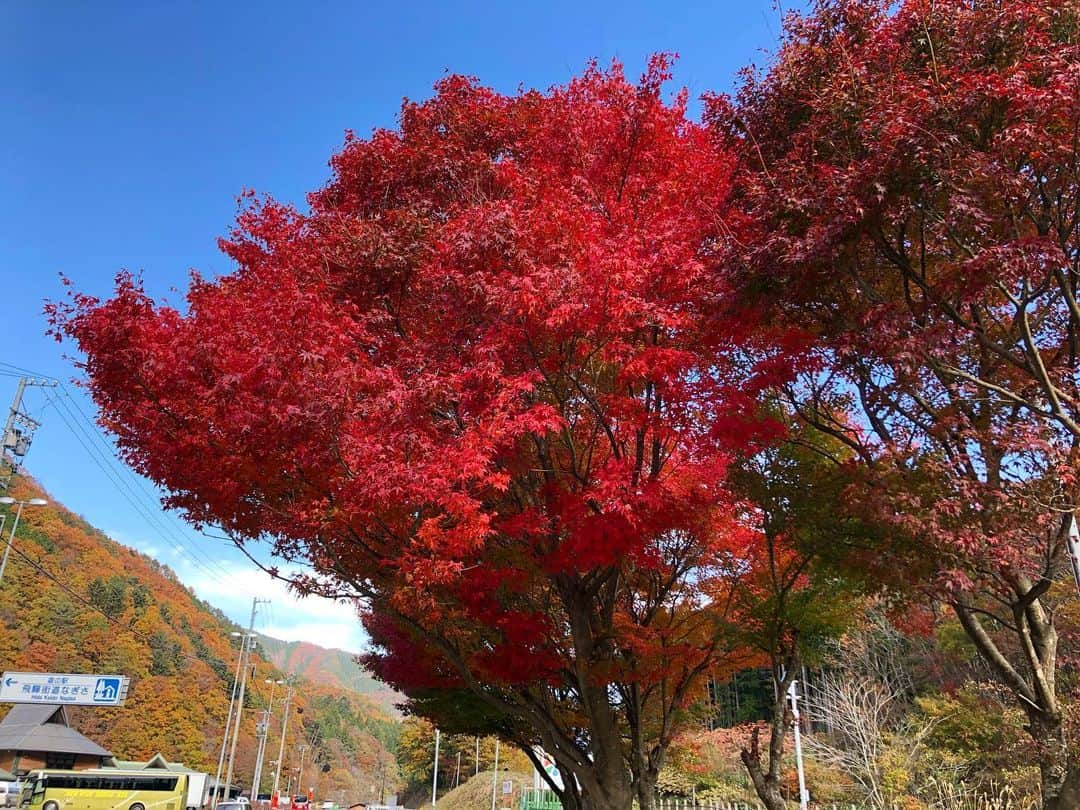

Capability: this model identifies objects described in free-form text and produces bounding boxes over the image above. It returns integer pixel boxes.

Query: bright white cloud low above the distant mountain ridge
[184,562,367,652]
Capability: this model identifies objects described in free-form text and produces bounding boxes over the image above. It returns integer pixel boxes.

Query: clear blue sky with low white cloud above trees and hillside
[0,0,794,650]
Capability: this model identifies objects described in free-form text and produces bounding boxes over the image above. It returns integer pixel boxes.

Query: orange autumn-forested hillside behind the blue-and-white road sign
[0,478,397,800]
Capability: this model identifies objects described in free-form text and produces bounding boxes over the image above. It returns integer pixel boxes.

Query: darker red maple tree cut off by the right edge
[712,0,1080,808]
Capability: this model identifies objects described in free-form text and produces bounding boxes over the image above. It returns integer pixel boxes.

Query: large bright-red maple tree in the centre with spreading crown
[53,57,789,810]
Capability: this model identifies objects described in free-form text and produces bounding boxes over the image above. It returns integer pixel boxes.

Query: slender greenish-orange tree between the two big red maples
[727,419,875,810]
